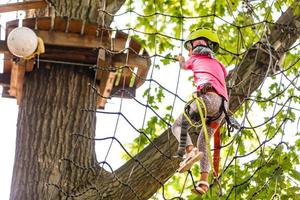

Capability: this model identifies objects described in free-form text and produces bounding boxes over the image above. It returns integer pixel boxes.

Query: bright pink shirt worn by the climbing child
[185,55,229,101]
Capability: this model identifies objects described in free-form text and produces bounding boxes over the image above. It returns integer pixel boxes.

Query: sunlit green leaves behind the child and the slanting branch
[112,0,300,199]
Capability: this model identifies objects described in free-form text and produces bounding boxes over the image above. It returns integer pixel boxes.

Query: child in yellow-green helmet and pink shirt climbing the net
[172,28,228,195]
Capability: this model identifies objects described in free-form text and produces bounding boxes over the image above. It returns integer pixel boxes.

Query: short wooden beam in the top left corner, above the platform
[0,1,47,13]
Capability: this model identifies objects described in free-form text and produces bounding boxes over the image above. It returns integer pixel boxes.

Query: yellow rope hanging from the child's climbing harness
[183,95,214,177]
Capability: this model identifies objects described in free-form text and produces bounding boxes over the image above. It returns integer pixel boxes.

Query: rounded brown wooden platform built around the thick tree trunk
[0,17,150,108]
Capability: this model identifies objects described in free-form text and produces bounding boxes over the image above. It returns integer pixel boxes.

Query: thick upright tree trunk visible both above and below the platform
[10,0,125,200]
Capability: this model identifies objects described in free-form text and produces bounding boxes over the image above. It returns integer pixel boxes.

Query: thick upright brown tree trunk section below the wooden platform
[11,65,96,199]
